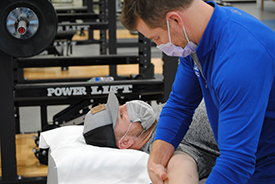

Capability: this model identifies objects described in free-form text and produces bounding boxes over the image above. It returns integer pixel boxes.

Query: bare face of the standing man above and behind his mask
[136,18,187,47]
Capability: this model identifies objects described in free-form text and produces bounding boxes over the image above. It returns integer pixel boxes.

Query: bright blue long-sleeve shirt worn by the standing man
[155,2,275,184]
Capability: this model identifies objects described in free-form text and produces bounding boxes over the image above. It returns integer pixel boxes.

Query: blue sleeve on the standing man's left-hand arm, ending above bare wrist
[155,58,202,149]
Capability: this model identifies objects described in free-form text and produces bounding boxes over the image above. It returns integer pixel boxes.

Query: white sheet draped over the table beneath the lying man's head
[39,125,151,184]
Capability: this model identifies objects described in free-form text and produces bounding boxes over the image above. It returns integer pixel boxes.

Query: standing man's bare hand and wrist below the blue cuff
[148,140,174,184]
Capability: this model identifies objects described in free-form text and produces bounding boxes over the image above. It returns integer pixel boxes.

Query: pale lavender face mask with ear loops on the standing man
[157,19,197,57]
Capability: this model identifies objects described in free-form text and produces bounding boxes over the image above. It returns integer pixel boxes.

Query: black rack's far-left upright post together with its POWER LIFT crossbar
[0,51,177,184]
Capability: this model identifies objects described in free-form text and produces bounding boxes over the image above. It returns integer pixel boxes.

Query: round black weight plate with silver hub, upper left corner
[0,0,58,57]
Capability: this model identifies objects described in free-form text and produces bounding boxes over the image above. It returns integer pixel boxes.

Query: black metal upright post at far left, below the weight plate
[0,51,17,181]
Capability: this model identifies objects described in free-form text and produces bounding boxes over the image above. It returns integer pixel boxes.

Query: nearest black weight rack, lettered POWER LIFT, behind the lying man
[0,1,178,184]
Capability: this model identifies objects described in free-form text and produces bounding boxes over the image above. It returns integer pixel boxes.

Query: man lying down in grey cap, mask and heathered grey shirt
[83,91,219,184]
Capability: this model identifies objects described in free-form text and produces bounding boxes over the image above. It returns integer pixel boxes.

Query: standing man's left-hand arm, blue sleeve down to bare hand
[148,58,202,184]
